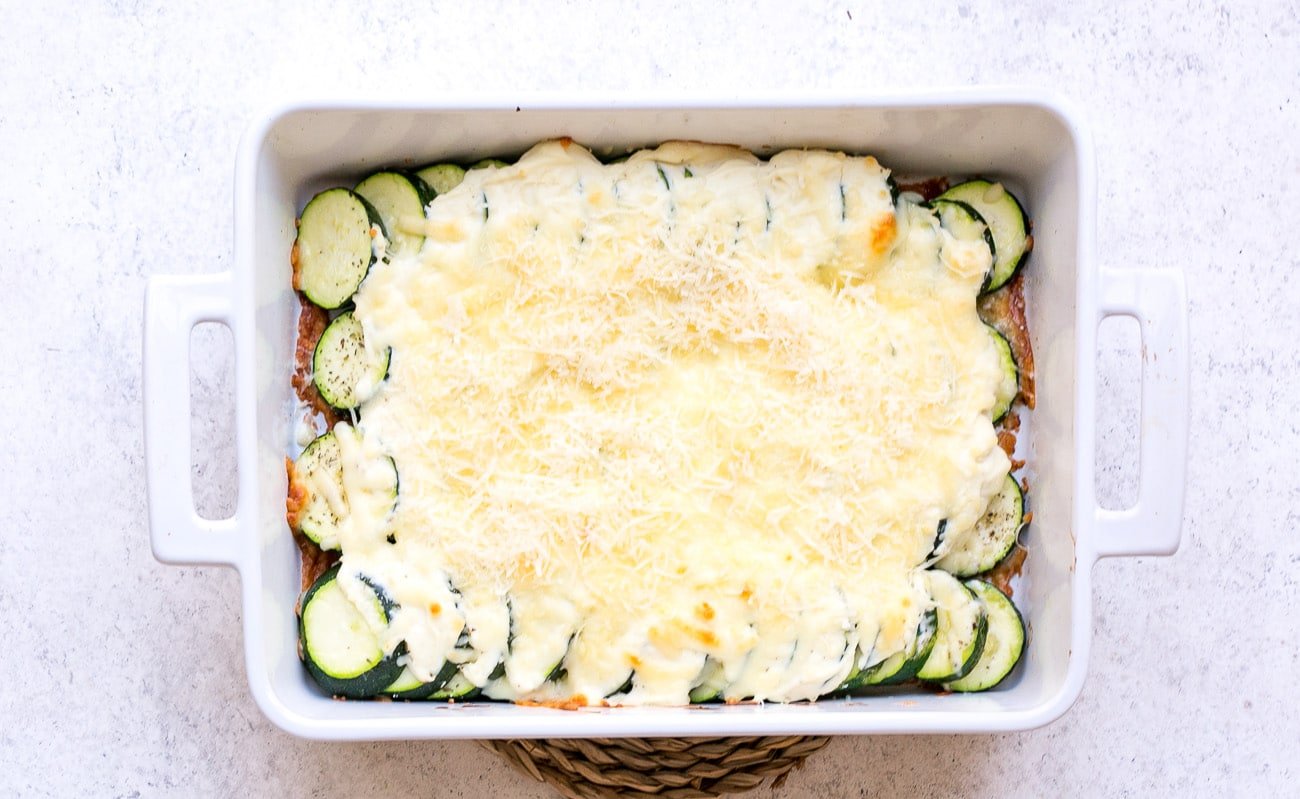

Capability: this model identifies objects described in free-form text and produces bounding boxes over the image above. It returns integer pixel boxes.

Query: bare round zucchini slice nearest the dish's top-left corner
[294,188,387,311]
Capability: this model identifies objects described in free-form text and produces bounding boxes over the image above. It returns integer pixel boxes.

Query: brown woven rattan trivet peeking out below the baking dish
[481,735,829,799]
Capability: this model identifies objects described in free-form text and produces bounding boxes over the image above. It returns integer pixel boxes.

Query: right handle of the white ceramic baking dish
[1096,269,1190,557]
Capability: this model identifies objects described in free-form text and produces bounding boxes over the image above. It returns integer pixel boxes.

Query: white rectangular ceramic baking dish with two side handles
[144,91,1188,739]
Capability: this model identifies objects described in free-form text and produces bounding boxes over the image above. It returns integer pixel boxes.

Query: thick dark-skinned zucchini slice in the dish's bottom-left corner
[298,565,403,699]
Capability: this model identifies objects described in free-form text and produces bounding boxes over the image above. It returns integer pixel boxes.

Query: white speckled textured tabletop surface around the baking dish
[0,0,1300,798]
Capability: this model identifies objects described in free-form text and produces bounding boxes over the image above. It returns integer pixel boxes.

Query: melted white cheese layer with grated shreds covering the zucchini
[339,142,1009,704]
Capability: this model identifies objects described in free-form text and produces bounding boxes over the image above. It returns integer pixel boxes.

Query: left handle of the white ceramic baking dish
[144,272,238,565]
